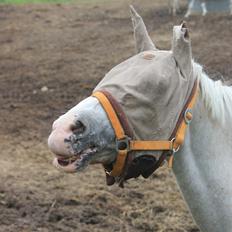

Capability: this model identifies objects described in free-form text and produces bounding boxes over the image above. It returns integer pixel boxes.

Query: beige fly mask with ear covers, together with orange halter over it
[93,7,198,185]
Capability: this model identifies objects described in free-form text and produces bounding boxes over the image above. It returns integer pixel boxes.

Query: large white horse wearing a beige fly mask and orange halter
[48,6,232,232]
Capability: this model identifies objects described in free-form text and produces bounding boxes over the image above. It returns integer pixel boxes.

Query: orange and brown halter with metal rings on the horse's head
[92,80,198,177]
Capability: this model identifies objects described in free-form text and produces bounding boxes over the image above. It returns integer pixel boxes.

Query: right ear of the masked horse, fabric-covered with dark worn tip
[172,22,192,79]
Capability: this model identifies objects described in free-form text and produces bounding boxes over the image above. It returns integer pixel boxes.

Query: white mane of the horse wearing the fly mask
[193,62,232,125]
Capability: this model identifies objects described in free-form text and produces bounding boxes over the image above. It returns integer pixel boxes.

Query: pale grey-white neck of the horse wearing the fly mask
[173,69,232,232]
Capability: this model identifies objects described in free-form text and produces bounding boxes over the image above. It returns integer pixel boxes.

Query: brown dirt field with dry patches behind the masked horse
[0,0,232,232]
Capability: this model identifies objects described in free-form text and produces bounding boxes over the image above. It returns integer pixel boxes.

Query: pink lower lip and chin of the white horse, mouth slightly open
[53,148,97,173]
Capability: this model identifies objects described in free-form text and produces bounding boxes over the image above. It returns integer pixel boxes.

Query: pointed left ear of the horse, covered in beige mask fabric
[130,6,157,53]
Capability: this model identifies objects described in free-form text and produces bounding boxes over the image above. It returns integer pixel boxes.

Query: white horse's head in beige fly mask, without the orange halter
[48,7,195,187]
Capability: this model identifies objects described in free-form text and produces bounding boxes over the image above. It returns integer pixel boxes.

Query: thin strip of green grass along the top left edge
[0,0,107,4]
